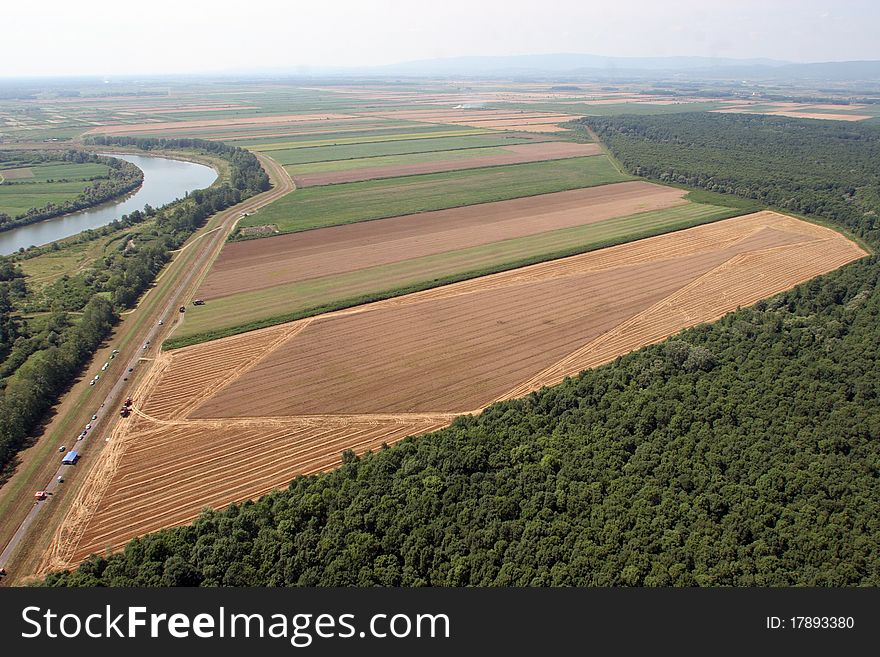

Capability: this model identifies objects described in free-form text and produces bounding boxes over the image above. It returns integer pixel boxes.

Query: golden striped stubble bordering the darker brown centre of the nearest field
[42,209,861,572]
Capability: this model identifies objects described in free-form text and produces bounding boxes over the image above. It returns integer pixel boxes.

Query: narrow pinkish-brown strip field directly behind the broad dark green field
[293,141,602,187]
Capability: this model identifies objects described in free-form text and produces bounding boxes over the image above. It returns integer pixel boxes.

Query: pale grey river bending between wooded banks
[0,153,217,255]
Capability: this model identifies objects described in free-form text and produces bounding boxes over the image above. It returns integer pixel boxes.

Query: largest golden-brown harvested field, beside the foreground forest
[41,211,865,571]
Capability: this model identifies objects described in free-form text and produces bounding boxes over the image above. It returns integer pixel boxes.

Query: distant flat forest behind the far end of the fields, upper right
[582,113,880,241]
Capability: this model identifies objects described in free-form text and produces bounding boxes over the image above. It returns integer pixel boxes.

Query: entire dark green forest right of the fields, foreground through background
[45,115,880,586]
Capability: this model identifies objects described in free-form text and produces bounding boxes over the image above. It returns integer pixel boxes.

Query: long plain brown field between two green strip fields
[198,181,686,299]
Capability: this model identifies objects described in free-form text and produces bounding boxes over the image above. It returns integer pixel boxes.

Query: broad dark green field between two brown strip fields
[238,155,631,233]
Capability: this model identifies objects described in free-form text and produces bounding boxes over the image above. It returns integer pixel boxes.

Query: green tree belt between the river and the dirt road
[0,137,269,478]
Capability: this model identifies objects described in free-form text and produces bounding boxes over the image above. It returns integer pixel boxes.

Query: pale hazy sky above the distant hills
[0,0,880,77]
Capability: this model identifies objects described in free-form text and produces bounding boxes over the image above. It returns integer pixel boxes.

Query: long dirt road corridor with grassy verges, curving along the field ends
[0,155,294,584]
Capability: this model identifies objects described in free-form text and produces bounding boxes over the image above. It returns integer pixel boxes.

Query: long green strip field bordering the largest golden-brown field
[172,203,740,346]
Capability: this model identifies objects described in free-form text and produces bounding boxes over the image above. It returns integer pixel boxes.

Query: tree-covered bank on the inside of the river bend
[0,150,144,231]
